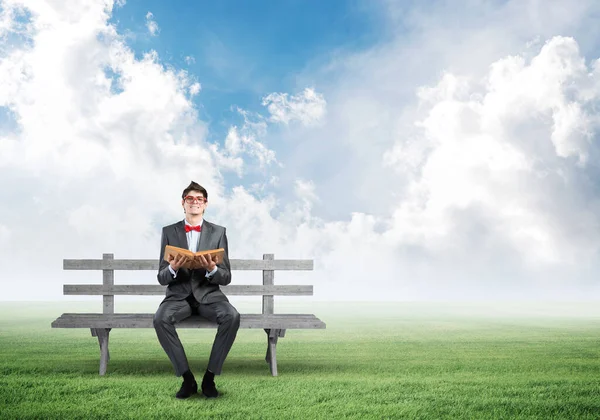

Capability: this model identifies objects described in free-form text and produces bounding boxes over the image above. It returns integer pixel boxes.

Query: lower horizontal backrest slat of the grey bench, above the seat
[63,284,313,296]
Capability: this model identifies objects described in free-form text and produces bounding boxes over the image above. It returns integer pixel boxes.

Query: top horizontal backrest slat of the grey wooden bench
[63,254,313,270]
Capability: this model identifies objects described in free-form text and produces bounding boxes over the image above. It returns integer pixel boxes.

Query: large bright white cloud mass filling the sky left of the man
[0,2,222,299]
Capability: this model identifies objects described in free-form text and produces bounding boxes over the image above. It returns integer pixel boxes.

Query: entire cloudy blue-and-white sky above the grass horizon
[0,0,600,300]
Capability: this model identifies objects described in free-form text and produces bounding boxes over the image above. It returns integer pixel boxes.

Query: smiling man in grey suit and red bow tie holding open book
[154,181,240,398]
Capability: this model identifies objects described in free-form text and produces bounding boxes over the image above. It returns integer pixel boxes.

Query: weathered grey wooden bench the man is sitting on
[52,254,325,376]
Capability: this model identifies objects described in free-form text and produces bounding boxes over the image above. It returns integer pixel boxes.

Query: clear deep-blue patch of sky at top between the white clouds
[111,0,385,141]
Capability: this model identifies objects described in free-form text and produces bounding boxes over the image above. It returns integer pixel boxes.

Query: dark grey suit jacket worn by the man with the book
[157,220,231,303]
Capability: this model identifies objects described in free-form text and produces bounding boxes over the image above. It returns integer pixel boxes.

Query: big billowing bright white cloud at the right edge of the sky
[384,37,600,274]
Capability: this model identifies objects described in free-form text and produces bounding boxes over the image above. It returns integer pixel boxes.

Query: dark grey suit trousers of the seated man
[154,296,240,376]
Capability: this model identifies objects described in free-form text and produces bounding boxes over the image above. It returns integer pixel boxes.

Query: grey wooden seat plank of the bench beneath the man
[52,313,325,329]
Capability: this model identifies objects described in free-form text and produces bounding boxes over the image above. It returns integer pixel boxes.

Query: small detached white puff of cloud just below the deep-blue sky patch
[262,88,327,126]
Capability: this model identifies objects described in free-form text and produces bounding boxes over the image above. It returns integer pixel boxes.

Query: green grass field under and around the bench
[0,301,600,419]
